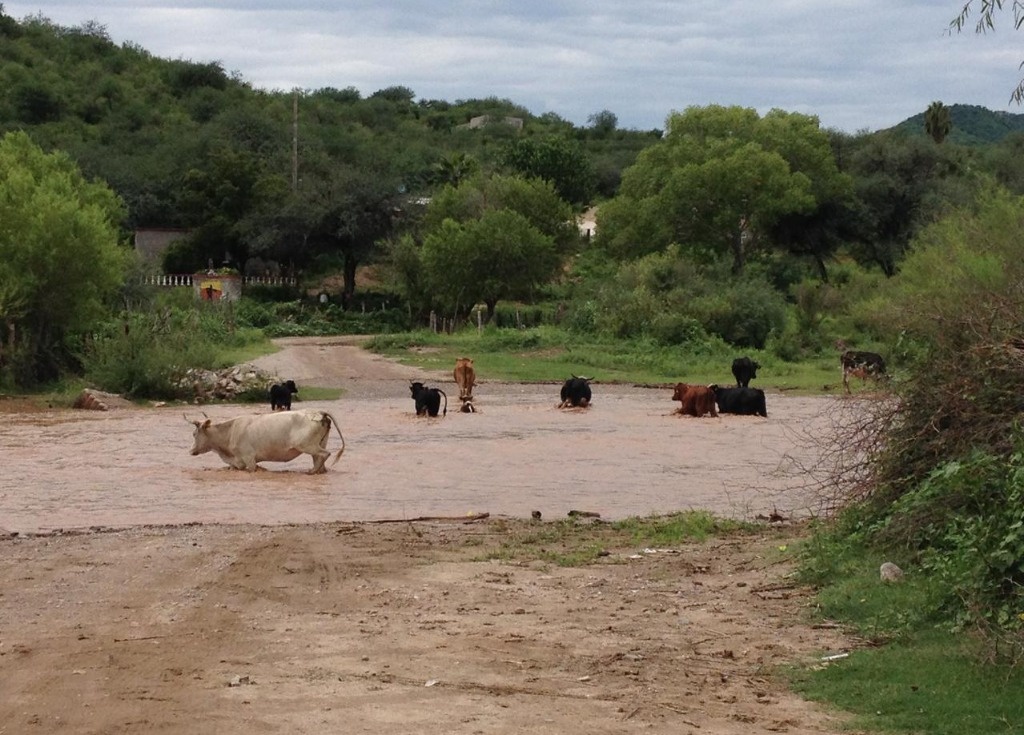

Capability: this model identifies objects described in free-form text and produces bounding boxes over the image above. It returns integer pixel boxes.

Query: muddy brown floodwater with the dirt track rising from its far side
[0,340,837,531]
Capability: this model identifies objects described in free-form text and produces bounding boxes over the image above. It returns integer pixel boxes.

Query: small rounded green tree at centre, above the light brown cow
[422,210,561,321]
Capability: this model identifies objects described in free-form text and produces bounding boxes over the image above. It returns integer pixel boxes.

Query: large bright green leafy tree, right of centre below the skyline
[597,105,850,273]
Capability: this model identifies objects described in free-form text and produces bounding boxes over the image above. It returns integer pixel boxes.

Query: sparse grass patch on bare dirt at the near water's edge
[485,511,754,566]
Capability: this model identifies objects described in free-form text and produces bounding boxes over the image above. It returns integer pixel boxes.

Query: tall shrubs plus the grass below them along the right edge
[798,189,1024,734]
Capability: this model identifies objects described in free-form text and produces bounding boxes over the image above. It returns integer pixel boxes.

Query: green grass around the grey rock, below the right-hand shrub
[785,516,1024,735]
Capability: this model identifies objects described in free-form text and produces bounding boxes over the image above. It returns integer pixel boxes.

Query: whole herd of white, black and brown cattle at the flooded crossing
[185,343,886,474]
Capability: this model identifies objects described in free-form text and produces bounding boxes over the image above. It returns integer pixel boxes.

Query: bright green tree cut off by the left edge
[0,132,128,385]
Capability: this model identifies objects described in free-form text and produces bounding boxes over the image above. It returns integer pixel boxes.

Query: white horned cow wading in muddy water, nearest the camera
[185,410,345,475]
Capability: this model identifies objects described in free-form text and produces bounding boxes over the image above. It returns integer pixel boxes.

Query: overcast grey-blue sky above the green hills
[0,0,1024,133]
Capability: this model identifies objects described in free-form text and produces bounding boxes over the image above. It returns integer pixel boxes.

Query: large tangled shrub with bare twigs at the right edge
[806,190,1024,647]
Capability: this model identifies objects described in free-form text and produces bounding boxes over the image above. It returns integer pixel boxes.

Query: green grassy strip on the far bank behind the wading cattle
[367,327,839,392]
